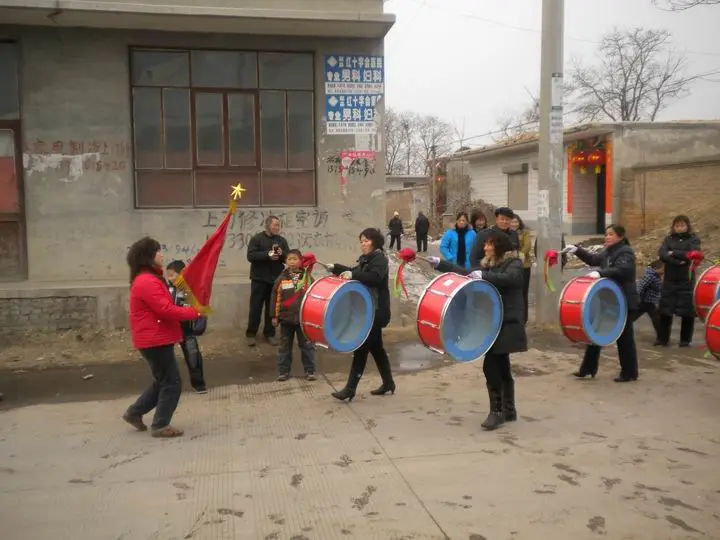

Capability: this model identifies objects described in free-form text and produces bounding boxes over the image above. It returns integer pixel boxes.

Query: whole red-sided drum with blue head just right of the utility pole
[559,276,628,347]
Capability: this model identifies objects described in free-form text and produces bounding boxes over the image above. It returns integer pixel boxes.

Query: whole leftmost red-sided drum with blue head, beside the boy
[300,276,375,352]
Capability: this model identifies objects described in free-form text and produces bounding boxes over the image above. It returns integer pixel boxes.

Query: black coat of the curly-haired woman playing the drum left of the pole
[437,253,527,354]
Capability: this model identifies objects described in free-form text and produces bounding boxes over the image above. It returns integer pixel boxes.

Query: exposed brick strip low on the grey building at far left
[0,296,97,331]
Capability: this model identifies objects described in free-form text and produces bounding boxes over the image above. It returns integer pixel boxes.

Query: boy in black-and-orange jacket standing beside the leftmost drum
[270,249,315,381]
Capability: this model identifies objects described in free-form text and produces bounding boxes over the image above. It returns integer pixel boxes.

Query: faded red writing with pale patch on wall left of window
[23,138,131,182]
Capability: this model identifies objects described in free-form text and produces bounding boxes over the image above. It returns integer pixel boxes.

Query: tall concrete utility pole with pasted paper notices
[535,0,565,324]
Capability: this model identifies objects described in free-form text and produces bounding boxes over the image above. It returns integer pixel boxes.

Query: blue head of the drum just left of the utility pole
[440,280,503,362]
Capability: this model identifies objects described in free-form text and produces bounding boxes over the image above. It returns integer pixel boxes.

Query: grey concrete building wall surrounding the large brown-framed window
[0,27,385,286]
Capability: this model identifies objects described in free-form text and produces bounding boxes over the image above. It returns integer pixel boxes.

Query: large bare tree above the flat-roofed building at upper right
[570,28,699,122]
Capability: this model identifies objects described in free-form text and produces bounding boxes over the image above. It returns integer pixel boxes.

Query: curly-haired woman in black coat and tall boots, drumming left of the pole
[428,231,527,430]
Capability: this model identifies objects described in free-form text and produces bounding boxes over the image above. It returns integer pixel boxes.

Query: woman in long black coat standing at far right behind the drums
[655,215,700,347]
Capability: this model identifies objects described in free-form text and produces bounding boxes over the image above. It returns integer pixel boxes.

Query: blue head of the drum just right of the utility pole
[582,278,628,347]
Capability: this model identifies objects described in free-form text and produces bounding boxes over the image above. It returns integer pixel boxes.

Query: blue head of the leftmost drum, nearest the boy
[323,281,375,353]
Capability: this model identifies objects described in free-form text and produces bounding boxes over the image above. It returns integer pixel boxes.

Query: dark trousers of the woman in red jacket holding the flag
[128,345,182,429]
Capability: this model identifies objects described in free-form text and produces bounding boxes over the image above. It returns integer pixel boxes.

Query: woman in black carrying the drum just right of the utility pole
[565,225,639,382]
